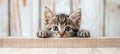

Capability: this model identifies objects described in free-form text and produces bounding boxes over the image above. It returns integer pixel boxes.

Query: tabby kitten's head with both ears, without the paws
[44,7,81,37]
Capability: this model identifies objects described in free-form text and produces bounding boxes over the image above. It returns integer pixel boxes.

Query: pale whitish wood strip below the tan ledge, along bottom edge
[0,48,120,54]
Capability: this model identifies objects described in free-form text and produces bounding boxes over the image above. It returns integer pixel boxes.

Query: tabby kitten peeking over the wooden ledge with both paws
[37,7,90,38]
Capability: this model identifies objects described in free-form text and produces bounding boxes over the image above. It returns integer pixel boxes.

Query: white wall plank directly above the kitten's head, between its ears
[55,0,72,15]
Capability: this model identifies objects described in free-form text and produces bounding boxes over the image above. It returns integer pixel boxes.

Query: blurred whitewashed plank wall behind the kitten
[0,0,120,37]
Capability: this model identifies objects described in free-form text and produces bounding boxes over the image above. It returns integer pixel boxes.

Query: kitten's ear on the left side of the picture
[44,7,54,24]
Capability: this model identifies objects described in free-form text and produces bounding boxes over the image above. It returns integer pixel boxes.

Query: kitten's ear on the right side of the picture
[69,9,81,25]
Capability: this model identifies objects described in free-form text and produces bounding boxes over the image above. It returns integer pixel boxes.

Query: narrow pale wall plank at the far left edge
[0,0,8,37]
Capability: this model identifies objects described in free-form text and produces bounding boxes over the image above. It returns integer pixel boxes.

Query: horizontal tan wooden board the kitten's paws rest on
[0,37,120,48]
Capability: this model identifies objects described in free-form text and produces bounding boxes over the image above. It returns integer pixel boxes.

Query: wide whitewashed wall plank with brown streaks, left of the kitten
[10,0,39,37]
